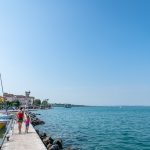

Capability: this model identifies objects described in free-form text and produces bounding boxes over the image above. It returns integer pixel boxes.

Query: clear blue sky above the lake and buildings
[0,0,150,106]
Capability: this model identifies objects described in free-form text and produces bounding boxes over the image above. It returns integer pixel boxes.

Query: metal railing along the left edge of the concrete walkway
[0,118,15,150]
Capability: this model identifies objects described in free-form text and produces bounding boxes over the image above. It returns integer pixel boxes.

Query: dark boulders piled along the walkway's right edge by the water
[29,112,70,150]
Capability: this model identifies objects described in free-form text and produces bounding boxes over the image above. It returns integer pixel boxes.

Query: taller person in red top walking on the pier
[17,107,24,134]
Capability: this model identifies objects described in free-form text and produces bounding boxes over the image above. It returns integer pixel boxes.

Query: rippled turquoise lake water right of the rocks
[34,107,150,150]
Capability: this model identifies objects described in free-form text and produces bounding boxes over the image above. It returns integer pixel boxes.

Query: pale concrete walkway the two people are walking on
[2,120,46,150]
